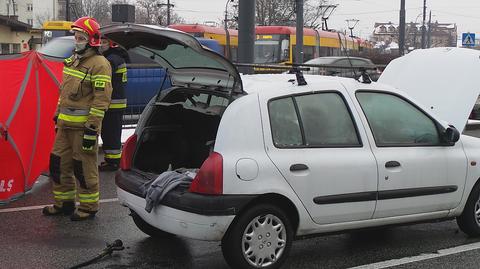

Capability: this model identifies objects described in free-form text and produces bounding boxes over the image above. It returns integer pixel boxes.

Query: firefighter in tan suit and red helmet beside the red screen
[42,17,112,221]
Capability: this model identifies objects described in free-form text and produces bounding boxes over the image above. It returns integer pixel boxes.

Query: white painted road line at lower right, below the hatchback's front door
[349,242,480,269]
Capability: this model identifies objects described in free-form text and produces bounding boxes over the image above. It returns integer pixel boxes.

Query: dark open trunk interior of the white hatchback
[133,89,228,174]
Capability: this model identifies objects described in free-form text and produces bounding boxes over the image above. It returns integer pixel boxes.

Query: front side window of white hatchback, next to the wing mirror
[356,92,440,146]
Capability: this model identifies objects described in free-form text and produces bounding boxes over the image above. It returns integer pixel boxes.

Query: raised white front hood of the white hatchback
[378,48,480,132]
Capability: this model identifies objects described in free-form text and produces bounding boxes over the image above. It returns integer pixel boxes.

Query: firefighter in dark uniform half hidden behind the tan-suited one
[99,38,128,171]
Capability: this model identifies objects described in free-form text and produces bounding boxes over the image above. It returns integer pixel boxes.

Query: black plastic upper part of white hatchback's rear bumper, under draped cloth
[115,171,257,216]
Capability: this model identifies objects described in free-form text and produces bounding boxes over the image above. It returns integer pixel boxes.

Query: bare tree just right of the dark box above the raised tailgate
[135,0,185,26]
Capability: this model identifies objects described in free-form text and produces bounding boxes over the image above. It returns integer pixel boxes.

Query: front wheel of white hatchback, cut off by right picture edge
[457,184,480,237]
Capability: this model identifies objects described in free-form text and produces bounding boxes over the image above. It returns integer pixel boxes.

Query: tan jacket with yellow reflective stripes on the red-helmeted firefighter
[56,49,112,133]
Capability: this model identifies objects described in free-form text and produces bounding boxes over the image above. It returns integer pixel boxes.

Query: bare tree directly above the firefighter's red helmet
[71,0,112,25]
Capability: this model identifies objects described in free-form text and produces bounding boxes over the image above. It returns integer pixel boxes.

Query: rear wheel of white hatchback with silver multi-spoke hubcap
[222,204,293,269]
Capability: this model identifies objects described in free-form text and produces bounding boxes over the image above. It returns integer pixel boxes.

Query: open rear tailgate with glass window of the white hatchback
[101,23,243,93]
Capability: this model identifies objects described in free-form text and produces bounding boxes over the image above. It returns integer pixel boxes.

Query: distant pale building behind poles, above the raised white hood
[372,21,457,50]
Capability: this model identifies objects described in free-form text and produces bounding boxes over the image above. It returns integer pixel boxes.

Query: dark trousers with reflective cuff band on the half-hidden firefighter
[102,109,124,165]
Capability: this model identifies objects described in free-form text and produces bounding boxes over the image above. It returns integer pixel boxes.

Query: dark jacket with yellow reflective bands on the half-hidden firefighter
[103,48,127,111]
